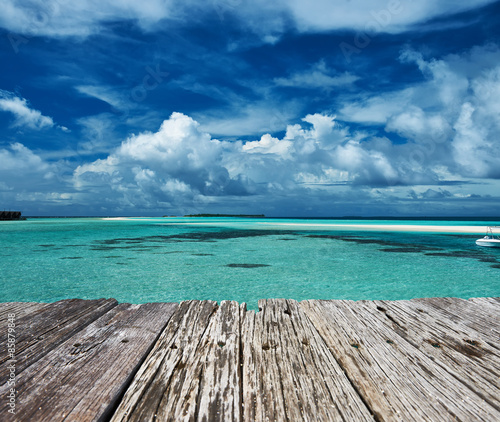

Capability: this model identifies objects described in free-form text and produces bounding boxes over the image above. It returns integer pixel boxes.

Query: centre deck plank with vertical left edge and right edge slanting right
[242,300,373,421]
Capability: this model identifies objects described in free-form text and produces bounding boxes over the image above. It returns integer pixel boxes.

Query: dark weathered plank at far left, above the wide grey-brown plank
[0,299,118,379]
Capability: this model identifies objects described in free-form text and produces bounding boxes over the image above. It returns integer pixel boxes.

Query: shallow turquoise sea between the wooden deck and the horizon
[0,218,500,309]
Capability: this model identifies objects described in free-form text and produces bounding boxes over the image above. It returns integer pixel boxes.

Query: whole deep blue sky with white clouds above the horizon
[0,0,500,217]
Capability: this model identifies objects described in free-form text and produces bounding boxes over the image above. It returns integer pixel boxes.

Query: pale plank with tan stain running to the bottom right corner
[300,301,500,421]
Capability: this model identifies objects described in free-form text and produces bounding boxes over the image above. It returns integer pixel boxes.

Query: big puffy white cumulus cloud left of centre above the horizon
[74,113,254,206]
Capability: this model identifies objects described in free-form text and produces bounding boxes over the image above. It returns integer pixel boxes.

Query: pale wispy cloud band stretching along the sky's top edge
[0,0,495,44]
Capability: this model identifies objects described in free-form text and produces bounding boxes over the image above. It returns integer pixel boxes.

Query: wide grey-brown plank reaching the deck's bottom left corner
[0,304,178,422]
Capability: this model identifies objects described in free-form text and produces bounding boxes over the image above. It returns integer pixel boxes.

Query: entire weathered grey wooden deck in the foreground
[0,298,500,422]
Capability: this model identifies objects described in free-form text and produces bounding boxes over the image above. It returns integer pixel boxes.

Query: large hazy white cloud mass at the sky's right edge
[339,44,500,183]
